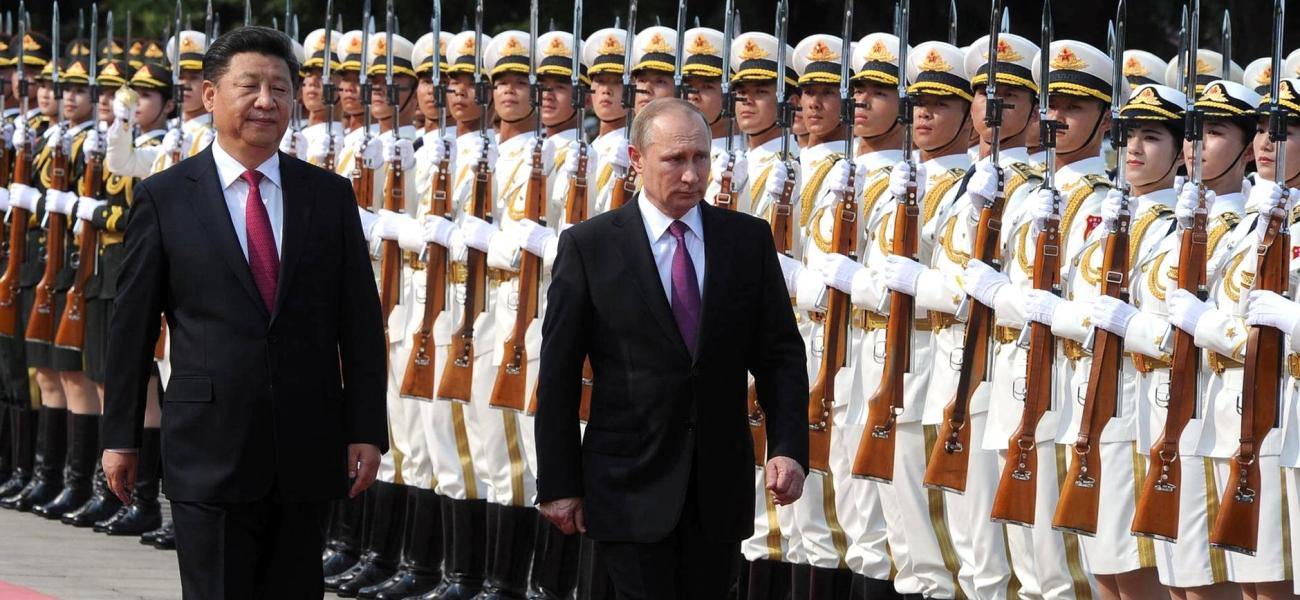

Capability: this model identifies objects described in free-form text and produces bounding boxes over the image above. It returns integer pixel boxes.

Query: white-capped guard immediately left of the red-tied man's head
[156,30,213,171]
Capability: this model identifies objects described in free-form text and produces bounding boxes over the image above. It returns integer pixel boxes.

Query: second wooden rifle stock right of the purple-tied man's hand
[853,175,920,483]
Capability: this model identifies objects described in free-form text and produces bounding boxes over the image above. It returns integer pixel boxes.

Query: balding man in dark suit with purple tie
[536,99,809,600]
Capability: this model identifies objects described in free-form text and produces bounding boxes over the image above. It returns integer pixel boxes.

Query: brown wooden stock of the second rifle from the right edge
[1131,200,1208,542]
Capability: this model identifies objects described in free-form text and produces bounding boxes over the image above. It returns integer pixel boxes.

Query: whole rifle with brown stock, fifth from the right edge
[924,0,1009,494]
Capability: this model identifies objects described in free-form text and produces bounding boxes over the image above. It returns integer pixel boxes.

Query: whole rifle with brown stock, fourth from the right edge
[992,0,1063,526]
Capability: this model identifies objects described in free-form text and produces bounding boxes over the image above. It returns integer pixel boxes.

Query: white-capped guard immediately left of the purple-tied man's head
[582,27,631,217]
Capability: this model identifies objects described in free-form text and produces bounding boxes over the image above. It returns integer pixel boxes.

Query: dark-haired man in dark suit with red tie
[104,27,387,600]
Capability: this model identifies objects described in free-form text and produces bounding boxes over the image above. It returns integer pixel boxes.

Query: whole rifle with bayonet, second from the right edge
[1131,0,1209,542]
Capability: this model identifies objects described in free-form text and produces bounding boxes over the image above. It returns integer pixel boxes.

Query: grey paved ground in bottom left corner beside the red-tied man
[0,510,181,600]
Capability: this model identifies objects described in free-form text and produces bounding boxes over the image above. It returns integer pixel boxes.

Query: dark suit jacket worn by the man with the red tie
[103,148,387,503]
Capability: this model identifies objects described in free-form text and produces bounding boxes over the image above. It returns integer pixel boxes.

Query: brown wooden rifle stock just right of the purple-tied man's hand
[809,174,858,473]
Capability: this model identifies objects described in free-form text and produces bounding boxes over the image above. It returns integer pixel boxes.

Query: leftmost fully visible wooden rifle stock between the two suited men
[400,142,451,400]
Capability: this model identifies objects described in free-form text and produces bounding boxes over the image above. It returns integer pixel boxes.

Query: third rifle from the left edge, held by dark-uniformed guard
[55,3,102,351]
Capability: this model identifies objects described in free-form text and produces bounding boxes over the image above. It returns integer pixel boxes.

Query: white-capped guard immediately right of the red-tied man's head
[299,29,343,169]
